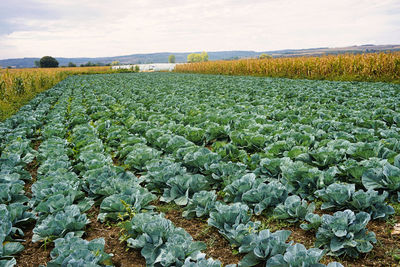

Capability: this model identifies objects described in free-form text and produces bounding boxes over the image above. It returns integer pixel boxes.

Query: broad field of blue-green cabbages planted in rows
[0,73,400,267]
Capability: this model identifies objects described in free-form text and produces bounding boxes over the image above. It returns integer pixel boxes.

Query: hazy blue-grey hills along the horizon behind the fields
[0,44,400,68]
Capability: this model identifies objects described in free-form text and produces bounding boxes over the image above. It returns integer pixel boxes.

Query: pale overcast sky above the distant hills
[0,0,400,59]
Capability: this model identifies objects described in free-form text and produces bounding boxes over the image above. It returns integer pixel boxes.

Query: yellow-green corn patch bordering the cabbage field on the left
[0,67,135,121]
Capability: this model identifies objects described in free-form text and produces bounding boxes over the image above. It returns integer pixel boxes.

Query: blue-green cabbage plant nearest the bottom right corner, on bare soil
[315,210,376,258]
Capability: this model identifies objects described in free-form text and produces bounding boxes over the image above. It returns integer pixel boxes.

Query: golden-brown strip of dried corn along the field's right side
[175,52,400,83]
